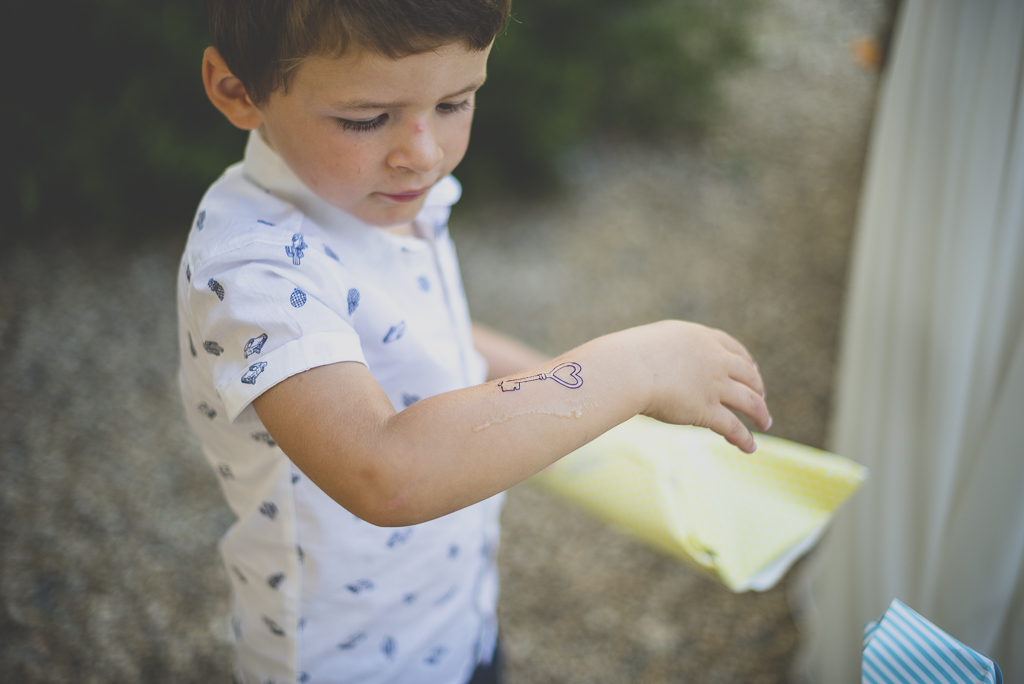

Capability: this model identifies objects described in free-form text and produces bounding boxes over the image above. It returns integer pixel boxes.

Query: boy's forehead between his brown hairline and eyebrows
[293,44,489,110]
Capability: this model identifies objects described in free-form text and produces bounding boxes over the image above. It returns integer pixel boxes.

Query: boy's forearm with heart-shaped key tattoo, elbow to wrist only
[378,327,645,519]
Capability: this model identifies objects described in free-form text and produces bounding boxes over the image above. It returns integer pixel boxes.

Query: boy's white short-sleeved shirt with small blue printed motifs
[178,133,502,684]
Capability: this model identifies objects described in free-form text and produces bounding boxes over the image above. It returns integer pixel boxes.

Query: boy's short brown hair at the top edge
[206,0,511,105]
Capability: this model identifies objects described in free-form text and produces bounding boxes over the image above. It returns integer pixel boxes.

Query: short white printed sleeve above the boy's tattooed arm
[186,232,367,421]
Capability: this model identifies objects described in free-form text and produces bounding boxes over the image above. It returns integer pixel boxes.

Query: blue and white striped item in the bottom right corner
[860,599,1002,684]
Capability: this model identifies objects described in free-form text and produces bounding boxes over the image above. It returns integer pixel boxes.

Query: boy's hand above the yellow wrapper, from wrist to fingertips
[631,320,772,453]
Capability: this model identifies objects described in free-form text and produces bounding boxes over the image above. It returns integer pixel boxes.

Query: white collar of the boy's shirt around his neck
[243,130,462,242]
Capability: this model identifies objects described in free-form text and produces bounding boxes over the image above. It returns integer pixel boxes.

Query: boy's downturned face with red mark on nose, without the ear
[253,44,489,227]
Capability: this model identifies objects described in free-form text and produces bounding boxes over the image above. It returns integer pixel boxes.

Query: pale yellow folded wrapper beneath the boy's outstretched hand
[534,416,867,592]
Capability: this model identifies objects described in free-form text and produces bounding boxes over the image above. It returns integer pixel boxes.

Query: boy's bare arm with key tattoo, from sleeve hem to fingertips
[253,322,771,526]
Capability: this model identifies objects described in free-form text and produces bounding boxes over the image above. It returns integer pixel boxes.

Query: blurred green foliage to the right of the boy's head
[464,0,754,197]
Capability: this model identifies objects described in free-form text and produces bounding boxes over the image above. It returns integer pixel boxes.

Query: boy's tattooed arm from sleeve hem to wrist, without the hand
[255,325,645,526]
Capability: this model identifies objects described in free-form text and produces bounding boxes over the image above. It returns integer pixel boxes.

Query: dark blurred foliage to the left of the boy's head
[0,0,245,231]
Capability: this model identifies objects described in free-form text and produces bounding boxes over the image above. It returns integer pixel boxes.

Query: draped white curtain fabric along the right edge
[796,0,1024,684]
